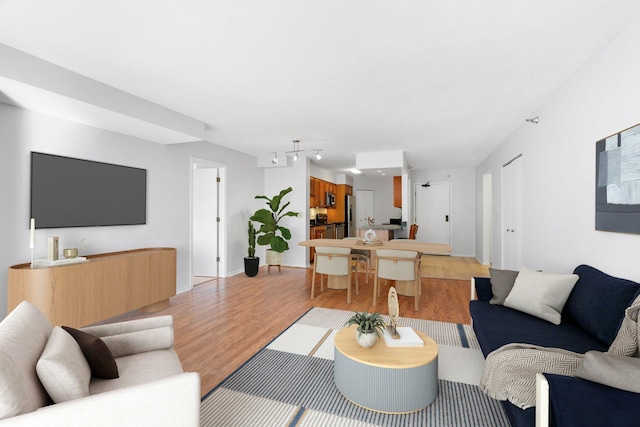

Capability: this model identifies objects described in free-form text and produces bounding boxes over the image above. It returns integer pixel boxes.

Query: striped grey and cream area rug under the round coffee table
[201,308,509,427]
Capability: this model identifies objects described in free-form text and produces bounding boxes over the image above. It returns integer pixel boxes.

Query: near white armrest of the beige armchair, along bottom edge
[0,372,200,427]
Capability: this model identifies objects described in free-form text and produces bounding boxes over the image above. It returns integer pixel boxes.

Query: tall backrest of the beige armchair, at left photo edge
[0,301,51,419]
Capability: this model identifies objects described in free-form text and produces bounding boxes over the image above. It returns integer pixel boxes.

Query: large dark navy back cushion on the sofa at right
[562,265,640,345]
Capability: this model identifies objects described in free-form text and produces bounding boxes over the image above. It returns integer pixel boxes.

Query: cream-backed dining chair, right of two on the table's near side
[373,249,422,311]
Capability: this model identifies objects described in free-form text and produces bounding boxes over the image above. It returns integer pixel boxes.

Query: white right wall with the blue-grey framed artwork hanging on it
[476,13,640,281]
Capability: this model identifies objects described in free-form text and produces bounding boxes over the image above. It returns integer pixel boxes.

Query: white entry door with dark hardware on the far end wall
[414,182,452,245]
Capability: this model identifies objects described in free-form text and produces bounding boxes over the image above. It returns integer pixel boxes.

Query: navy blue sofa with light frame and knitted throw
[469,265,640,427]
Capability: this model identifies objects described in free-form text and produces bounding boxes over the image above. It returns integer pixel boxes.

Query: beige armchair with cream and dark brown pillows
[0,301,200,427]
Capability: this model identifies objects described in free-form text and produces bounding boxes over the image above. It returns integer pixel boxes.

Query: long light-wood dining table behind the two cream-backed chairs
[298,239,452,296]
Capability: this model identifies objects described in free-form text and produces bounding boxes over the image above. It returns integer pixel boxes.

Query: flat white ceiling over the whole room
[0,0,640,171]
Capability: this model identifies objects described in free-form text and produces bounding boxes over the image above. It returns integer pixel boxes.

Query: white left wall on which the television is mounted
[0,104,263,316]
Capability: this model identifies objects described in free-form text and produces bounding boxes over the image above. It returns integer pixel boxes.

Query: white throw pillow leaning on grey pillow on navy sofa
[504,267,578,325]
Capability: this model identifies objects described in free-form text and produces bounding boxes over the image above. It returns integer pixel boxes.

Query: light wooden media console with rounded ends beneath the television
[7,248,176,327]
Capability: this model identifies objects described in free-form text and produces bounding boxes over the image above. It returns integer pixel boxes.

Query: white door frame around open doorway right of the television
[189,157,228,288]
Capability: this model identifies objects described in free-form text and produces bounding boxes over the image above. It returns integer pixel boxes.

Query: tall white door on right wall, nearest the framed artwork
[502,156,522,270]
